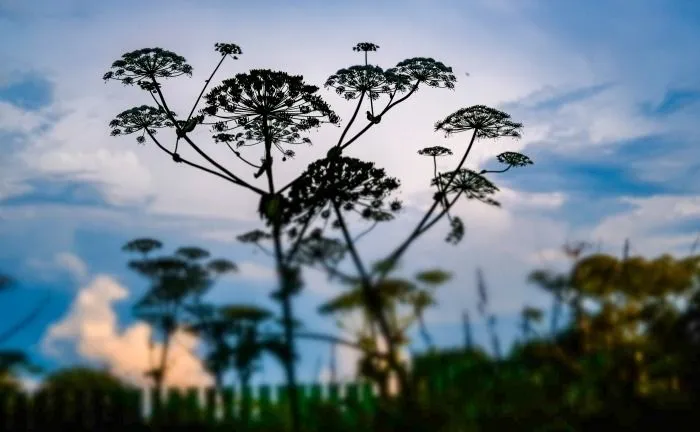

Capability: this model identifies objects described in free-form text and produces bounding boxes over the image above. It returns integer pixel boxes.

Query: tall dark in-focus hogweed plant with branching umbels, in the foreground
[104,42,532,431]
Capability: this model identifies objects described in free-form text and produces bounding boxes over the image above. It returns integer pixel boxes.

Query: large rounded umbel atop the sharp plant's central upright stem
[202,69,340,158]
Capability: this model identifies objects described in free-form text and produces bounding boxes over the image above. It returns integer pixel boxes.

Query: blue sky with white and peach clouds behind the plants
[0,0,700,392]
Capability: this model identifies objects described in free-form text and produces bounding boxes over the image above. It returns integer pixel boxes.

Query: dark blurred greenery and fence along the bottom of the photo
[1,243,700,431]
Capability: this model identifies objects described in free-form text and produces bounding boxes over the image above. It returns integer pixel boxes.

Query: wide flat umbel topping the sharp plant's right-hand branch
[435,105,523,139]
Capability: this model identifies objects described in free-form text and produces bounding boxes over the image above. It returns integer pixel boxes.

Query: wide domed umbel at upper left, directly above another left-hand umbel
[102,48,192,91]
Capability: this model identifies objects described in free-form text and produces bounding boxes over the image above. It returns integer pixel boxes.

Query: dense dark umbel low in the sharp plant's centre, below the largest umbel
[283,157,401,230]
